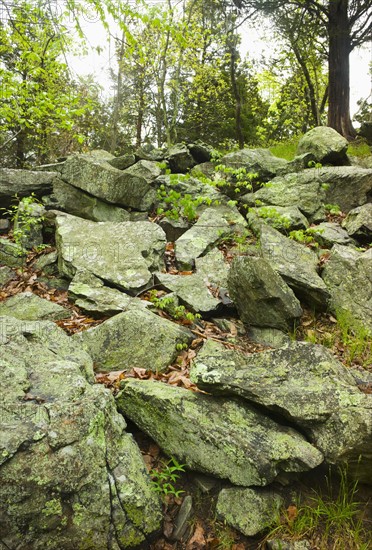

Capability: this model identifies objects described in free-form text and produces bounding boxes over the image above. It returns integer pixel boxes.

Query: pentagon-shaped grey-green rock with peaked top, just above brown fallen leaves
[72,304,193,372]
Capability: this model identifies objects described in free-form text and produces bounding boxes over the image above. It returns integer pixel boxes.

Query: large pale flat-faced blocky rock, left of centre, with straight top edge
[56,213,165,293]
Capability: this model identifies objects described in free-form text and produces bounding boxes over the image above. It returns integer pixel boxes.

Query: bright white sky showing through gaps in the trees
[68,7,372,120]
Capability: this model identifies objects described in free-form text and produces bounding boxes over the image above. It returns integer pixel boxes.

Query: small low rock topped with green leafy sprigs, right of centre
[247,206,309,231]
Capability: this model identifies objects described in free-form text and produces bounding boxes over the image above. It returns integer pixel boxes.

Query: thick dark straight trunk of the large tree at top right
[328,0,356,139]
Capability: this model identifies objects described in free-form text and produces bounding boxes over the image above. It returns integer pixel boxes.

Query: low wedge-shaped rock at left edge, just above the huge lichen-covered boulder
[0,292,72,321]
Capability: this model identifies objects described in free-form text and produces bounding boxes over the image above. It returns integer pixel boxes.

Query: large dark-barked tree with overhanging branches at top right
[233,0,372,139]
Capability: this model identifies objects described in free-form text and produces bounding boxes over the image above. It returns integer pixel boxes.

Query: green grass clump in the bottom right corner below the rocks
[265,469,370,550]
